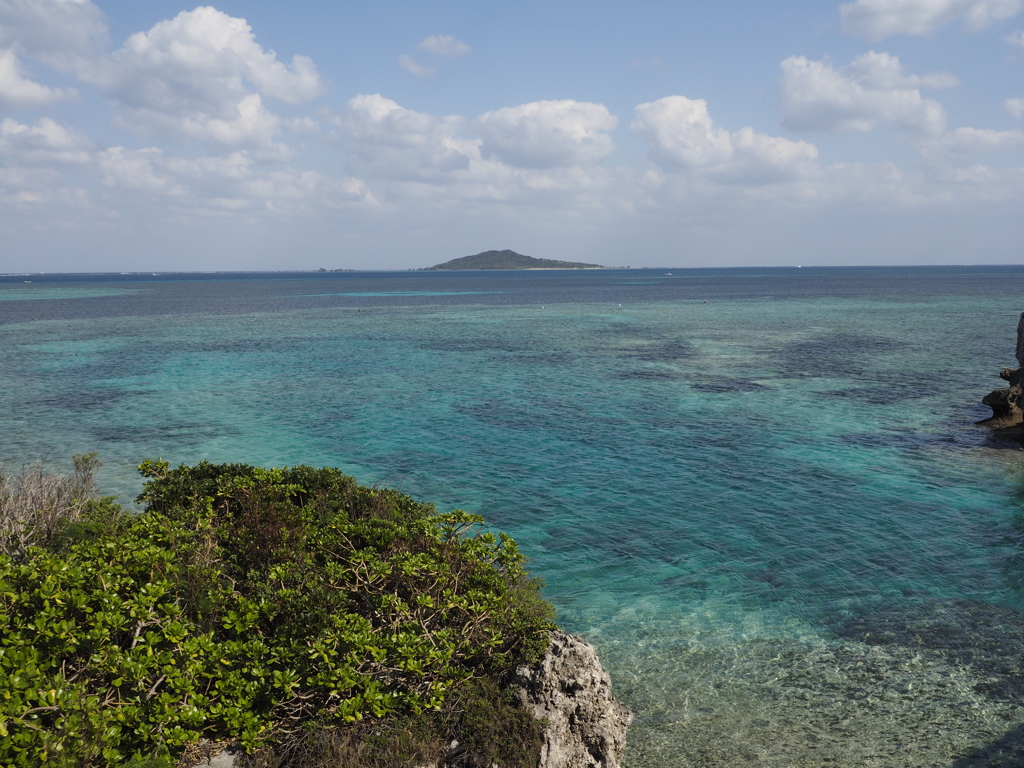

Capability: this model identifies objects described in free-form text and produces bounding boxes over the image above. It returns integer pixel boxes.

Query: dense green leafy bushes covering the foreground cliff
[0,455,554,768]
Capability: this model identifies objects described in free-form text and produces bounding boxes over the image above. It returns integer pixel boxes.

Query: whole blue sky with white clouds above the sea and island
[0,0,1024,272]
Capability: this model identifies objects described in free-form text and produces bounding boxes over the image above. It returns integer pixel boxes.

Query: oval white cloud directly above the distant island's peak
[473,100,618,168]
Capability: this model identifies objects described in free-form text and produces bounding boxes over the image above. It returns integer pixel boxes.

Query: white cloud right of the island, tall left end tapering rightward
[631,96,818,185]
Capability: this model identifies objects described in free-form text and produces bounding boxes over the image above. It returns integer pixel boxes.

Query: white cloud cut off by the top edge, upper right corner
[840,0,1024,40]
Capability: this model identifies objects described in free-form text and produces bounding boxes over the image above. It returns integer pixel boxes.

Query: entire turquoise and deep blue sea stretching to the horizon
[0,267,1024,768]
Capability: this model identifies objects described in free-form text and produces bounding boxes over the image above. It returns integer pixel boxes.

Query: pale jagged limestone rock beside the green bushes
[512,632,633,768]
